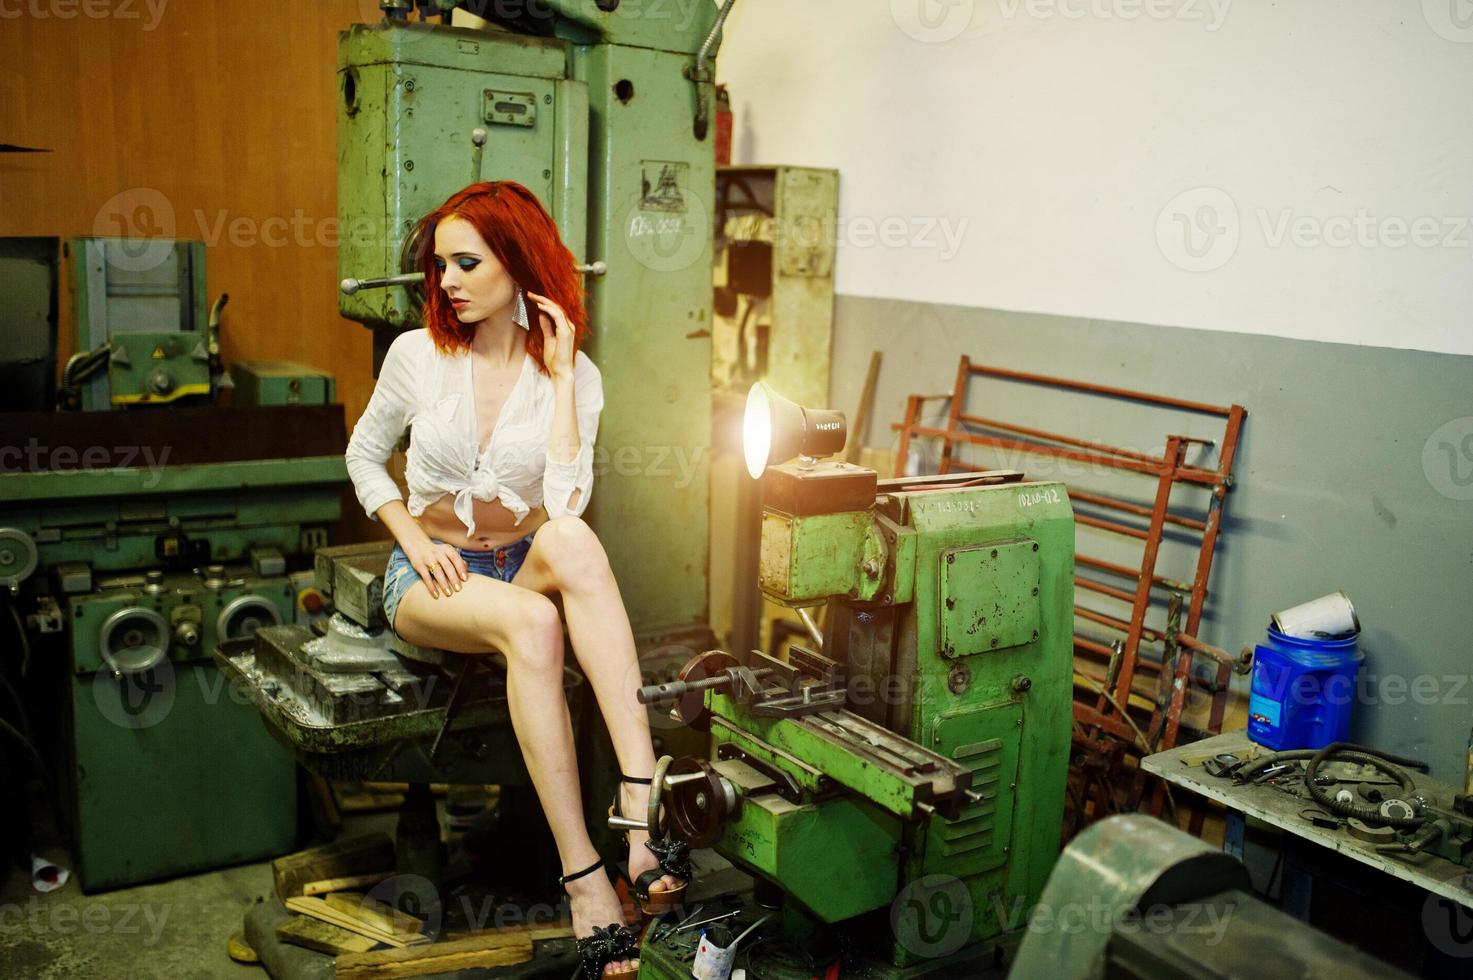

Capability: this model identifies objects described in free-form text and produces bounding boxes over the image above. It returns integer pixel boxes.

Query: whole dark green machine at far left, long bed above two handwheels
[0,405,346,892]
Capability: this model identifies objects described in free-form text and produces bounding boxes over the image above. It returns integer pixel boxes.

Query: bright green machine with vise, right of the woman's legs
[641,389,1074,980]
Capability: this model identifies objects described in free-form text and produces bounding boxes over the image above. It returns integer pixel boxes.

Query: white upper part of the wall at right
[719,0,1473,354]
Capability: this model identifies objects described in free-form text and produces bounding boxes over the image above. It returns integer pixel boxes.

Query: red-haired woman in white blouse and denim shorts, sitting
[348,181,689,977]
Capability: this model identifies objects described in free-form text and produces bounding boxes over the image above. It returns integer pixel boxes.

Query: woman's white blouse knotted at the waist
[346,327,604,535]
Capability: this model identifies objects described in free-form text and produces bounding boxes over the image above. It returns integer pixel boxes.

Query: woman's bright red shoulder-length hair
[407,180,588,374]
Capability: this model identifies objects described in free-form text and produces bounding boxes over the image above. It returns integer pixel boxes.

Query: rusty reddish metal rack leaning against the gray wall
[894,355,1248,830]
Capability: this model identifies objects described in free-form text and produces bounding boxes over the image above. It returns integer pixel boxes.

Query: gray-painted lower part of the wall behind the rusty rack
[831,296,1473,783]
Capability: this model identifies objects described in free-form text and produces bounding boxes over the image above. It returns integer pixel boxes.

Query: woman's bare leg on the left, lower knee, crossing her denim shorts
[395,575,632,970]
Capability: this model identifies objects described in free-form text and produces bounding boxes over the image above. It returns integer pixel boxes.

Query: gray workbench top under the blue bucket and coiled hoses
[1140,731,1473,911]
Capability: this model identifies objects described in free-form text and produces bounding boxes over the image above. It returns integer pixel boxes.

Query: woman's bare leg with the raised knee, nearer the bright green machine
[513,517,679,892]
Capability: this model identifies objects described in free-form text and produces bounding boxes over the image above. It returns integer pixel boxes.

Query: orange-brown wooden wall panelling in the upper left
[0,0,383,538]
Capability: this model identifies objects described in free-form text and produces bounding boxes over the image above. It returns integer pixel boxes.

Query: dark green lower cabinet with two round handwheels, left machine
[66,556,296,892]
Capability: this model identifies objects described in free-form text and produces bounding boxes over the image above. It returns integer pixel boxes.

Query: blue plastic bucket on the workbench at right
[1248,626,1365,752]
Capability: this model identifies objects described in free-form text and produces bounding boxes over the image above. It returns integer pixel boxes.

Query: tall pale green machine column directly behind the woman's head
[337,0,729,651]
